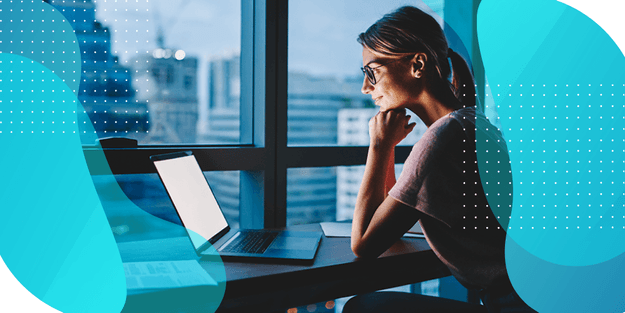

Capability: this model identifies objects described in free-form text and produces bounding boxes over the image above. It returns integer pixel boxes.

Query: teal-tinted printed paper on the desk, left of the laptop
[124,260,217,290]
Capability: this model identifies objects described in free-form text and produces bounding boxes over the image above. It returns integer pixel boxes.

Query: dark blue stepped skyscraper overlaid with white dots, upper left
[50,0,149,137]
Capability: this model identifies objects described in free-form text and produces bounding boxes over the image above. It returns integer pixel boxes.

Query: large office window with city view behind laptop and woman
[66,0,480,241]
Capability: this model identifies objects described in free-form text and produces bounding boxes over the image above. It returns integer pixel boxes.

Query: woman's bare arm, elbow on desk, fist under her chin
[352,111,419,257]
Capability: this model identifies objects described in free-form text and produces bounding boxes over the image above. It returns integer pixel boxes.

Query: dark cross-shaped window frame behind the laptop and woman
[83,0,484,228]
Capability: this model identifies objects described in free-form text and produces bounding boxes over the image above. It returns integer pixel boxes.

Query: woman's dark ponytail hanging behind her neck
[447,48,475,107]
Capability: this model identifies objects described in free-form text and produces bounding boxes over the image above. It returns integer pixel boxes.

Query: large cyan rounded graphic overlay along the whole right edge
[478,0,625,313]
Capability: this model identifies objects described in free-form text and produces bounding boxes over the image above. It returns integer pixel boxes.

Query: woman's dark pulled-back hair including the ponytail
[358,6,475,106]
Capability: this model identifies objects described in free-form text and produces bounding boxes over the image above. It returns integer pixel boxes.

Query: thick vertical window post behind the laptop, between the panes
[240,0,287,228]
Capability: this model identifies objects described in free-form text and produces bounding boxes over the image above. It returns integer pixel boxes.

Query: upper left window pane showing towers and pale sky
[49,0,241,144]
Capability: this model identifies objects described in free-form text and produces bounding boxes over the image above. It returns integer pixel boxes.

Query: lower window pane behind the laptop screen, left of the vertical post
[92,171,239,242]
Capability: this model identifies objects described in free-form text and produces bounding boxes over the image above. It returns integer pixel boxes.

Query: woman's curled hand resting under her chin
[369,109,417,149]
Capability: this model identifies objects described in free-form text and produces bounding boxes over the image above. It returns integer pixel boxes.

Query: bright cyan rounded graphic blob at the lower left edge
[0,53,126,312]
